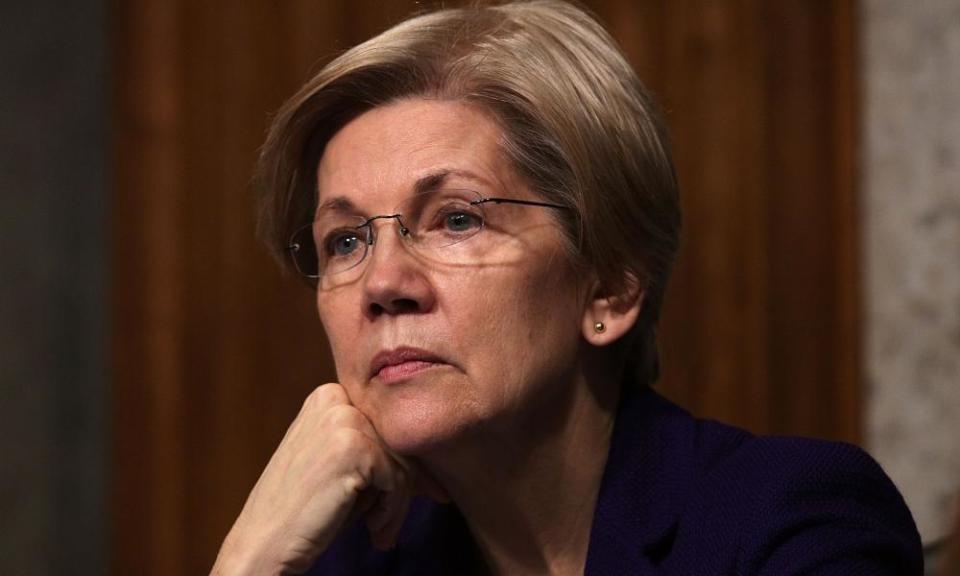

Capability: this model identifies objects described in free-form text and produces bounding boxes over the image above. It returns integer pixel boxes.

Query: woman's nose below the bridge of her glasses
[363,219,436,319]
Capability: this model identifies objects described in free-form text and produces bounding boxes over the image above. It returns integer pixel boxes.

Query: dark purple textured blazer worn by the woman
[310,390,923,576]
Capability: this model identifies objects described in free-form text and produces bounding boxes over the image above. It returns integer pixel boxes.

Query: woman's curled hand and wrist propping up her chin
[212,383,439,575]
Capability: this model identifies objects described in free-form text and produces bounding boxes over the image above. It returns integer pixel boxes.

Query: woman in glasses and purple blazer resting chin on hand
[214,1,921,574]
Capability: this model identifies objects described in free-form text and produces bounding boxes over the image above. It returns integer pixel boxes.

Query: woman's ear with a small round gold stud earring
[581,278,644,346]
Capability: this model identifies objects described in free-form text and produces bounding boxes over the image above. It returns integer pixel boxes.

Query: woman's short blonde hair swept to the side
[258,0,680,384]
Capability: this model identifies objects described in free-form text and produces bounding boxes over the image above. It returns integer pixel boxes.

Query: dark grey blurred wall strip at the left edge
[0,0,108,574]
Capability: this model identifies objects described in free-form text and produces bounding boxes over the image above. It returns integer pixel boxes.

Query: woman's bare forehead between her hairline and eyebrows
[317,99,518,208]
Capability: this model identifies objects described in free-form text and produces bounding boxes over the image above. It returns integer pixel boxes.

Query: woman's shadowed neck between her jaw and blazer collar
[423,372,619,574]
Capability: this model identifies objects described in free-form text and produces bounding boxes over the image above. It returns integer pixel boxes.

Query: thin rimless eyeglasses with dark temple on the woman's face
[287,189,567,286]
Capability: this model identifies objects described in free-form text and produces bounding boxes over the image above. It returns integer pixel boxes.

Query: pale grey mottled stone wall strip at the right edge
[861,0,960,542]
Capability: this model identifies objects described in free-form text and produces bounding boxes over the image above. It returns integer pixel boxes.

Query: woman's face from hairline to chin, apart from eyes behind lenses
[317,99,586,455]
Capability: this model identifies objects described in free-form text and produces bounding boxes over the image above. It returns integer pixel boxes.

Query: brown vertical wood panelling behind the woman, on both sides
[110,0,859,575]
